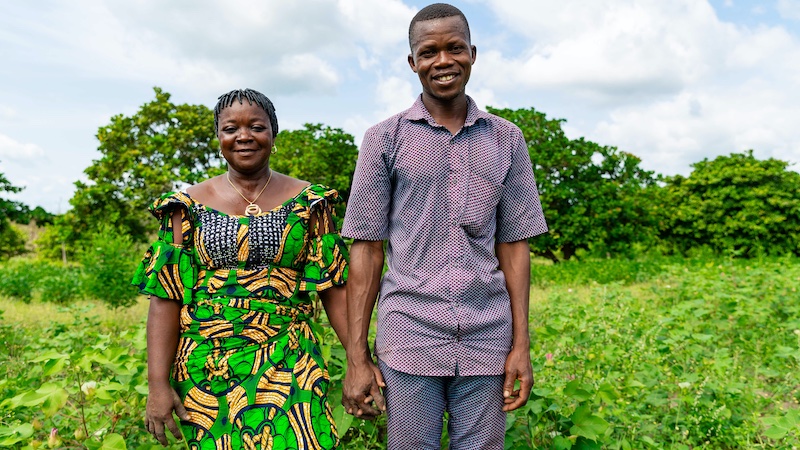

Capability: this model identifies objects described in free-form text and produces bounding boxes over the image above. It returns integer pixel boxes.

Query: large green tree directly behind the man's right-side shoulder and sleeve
[489,108,656,262]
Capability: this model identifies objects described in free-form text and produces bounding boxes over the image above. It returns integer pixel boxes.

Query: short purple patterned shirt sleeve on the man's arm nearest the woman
[342,126,393,241]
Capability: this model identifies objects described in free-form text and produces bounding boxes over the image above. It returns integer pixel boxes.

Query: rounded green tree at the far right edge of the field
[660,150,800,257]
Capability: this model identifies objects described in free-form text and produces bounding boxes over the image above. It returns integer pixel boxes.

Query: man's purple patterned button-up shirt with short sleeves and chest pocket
[342,96,547,376]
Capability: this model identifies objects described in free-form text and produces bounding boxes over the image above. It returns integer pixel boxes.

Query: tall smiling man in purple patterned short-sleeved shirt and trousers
[342,3,547,450]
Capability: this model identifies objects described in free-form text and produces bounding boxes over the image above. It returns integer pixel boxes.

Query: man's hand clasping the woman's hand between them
[342,360,386,419]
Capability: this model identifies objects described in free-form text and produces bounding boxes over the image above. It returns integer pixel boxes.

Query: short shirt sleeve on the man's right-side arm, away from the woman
[495,126,547,242]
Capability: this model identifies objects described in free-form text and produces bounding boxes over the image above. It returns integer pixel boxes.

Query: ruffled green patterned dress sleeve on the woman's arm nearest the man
[300,185,350,291]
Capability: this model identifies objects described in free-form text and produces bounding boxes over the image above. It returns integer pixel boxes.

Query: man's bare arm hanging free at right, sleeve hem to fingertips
[495,239,533,411]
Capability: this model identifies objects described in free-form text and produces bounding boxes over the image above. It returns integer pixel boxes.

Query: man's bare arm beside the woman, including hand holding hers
[342,240,386,418]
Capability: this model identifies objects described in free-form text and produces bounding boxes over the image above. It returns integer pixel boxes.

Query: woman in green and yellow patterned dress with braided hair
[133,89,347,449]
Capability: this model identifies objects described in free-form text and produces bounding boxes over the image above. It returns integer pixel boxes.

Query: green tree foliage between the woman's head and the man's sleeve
[270,123,358,217]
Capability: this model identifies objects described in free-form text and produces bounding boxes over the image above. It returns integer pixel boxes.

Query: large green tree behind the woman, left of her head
[61,88,223,241]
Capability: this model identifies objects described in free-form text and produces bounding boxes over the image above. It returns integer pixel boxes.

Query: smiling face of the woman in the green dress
[217,101,275,173]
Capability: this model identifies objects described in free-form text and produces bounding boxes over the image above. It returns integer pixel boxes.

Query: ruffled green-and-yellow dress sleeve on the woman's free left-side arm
[131,192,197,303]
